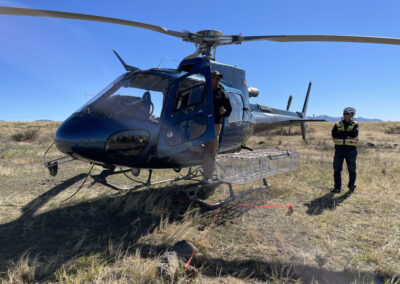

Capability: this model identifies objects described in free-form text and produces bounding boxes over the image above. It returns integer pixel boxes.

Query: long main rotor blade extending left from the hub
[0,6,187,38]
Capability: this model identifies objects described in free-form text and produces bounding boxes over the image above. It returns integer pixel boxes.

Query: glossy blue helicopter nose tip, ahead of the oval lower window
[54,113,124,161]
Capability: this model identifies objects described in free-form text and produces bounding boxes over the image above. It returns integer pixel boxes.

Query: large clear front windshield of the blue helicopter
[80,73,170,123]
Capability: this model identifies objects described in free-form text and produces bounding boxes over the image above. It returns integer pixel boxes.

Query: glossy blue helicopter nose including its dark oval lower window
[54,113,152,165]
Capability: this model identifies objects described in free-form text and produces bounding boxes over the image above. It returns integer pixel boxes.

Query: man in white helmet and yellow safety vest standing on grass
[331,107,358,193]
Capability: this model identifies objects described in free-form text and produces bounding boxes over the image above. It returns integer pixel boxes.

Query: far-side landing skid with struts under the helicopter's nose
[89,167,202,192]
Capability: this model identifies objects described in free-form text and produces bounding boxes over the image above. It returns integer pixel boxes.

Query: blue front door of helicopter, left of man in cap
[158,72,215,158]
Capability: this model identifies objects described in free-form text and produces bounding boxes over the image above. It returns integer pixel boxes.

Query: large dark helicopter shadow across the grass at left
[0,174,256,281]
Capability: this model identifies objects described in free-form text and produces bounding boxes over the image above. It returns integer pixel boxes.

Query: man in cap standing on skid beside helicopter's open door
[203,70,232,183]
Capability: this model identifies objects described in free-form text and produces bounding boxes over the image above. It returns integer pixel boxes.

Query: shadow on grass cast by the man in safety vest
[304,191,352,215]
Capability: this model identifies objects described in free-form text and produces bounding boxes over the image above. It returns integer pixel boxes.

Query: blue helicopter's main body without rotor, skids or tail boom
[54,58,254,168]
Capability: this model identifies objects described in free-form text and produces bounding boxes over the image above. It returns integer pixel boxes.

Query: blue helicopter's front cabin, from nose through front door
[55,69,214,167]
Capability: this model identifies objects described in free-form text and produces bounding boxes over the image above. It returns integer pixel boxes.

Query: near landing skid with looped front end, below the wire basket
[185,178,269,209]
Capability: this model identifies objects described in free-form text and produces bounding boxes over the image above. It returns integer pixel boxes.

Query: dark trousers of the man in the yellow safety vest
[333,147,357,189]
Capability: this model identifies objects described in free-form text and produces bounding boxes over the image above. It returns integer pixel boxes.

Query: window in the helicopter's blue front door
[173,74,206,113]
